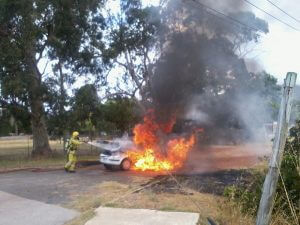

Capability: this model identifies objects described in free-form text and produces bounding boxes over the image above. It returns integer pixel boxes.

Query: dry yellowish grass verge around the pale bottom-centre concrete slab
[66,179,253,225]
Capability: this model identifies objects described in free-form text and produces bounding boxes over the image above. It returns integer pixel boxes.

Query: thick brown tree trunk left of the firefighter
[25,45,51,157]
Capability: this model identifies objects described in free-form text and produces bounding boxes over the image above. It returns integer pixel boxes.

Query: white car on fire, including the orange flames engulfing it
[91,110,195,172]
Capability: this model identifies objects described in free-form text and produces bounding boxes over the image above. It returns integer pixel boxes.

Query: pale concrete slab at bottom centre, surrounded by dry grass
[85,207,199,225]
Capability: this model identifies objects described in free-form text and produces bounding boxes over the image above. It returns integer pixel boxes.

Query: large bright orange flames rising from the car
[128,110,195,171]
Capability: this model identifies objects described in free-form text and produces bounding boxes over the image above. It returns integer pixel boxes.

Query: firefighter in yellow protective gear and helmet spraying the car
[65,131,81,173]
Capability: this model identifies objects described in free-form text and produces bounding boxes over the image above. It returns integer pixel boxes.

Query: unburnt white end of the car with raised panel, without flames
[90,139,132,170]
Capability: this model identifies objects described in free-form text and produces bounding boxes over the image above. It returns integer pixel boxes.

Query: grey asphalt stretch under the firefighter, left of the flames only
[0,165,137,205]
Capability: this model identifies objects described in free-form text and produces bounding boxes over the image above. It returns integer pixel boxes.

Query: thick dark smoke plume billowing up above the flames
[151,0,268,143]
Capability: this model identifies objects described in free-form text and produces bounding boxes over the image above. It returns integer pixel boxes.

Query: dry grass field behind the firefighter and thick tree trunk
[0,139,99,171]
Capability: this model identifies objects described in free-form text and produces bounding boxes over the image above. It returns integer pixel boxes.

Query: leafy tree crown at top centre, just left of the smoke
[108,0,160,56]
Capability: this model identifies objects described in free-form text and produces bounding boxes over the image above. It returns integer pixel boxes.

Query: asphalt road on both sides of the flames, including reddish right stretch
[0,145,269,204]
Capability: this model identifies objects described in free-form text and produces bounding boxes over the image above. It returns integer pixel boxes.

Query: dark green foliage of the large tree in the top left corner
[0,0,104,93]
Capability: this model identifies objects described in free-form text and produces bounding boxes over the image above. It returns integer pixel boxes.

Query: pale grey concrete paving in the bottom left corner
[0,191,79,225]
